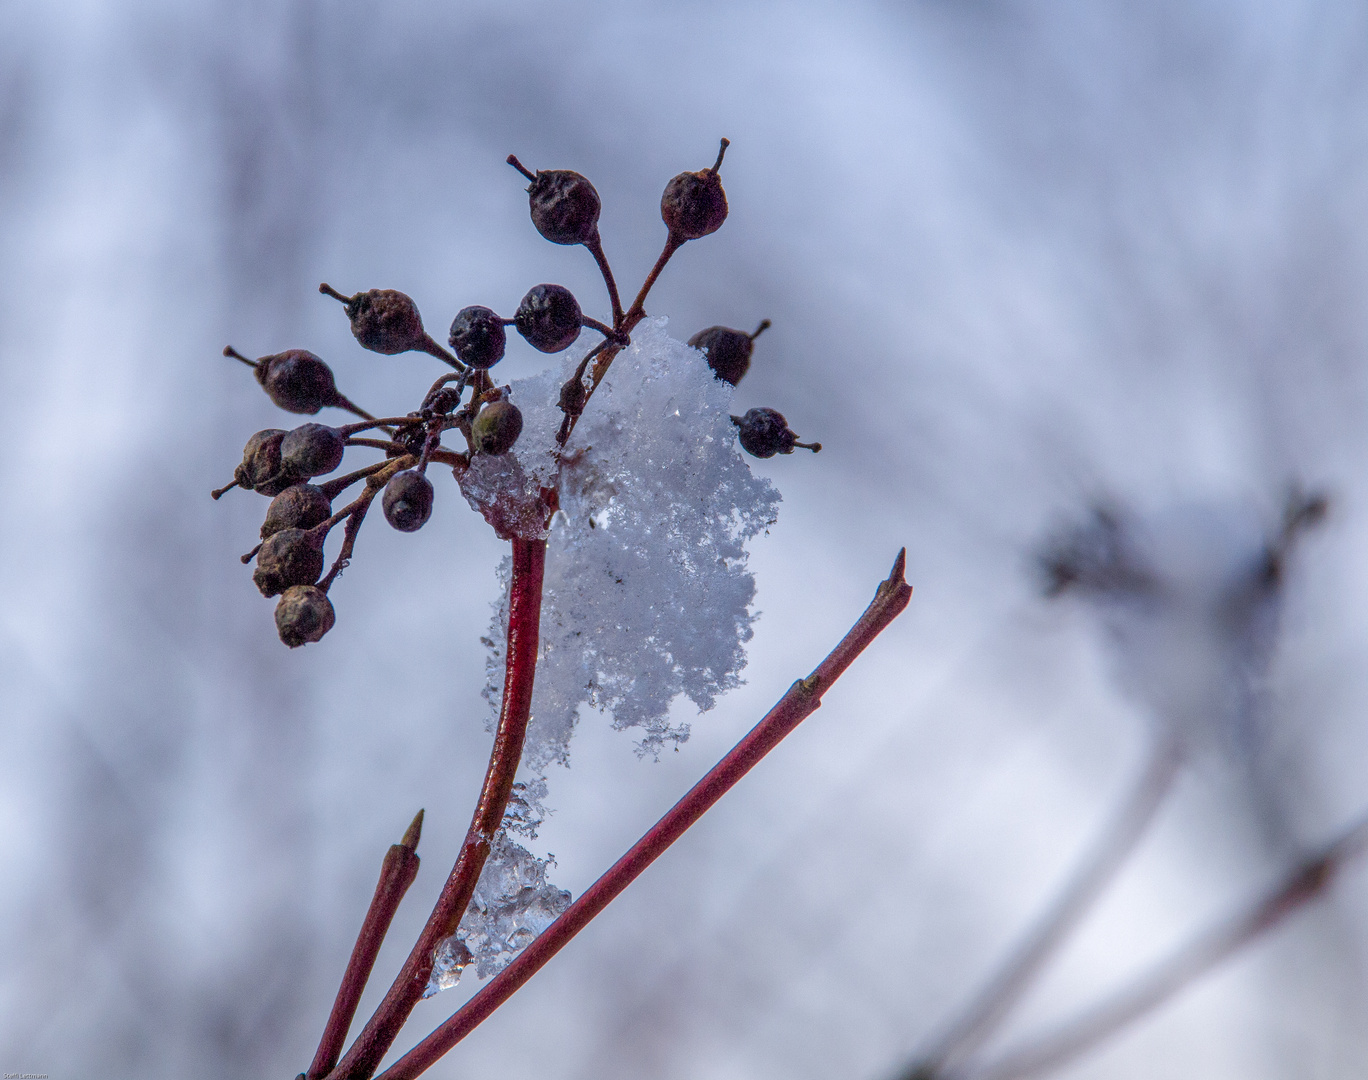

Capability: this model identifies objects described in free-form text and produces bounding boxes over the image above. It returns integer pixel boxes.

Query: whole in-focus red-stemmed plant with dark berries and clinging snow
[213,140,911,1080]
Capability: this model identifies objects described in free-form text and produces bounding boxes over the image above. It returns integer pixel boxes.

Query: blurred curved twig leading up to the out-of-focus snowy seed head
[904,735,1182,1080]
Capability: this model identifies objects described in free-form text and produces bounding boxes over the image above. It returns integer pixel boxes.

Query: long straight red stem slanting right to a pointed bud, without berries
[376,549,912,1080]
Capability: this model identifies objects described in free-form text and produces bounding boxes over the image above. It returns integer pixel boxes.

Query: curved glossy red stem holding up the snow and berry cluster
[328,539,546,1080]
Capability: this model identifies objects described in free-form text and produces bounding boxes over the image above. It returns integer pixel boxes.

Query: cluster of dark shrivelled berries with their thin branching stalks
[213,140,821,647]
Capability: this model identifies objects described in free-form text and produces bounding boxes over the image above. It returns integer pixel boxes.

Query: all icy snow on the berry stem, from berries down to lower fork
[428,319,778,994]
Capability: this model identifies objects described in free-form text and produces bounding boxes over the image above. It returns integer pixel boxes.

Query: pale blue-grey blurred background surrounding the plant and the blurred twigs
[0,0,1368,1080]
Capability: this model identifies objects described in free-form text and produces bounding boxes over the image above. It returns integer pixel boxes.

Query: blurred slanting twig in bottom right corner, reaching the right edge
[962,816,1368,1080]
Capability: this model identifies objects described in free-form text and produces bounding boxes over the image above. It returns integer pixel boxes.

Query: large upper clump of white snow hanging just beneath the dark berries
[484,319,778,771]
